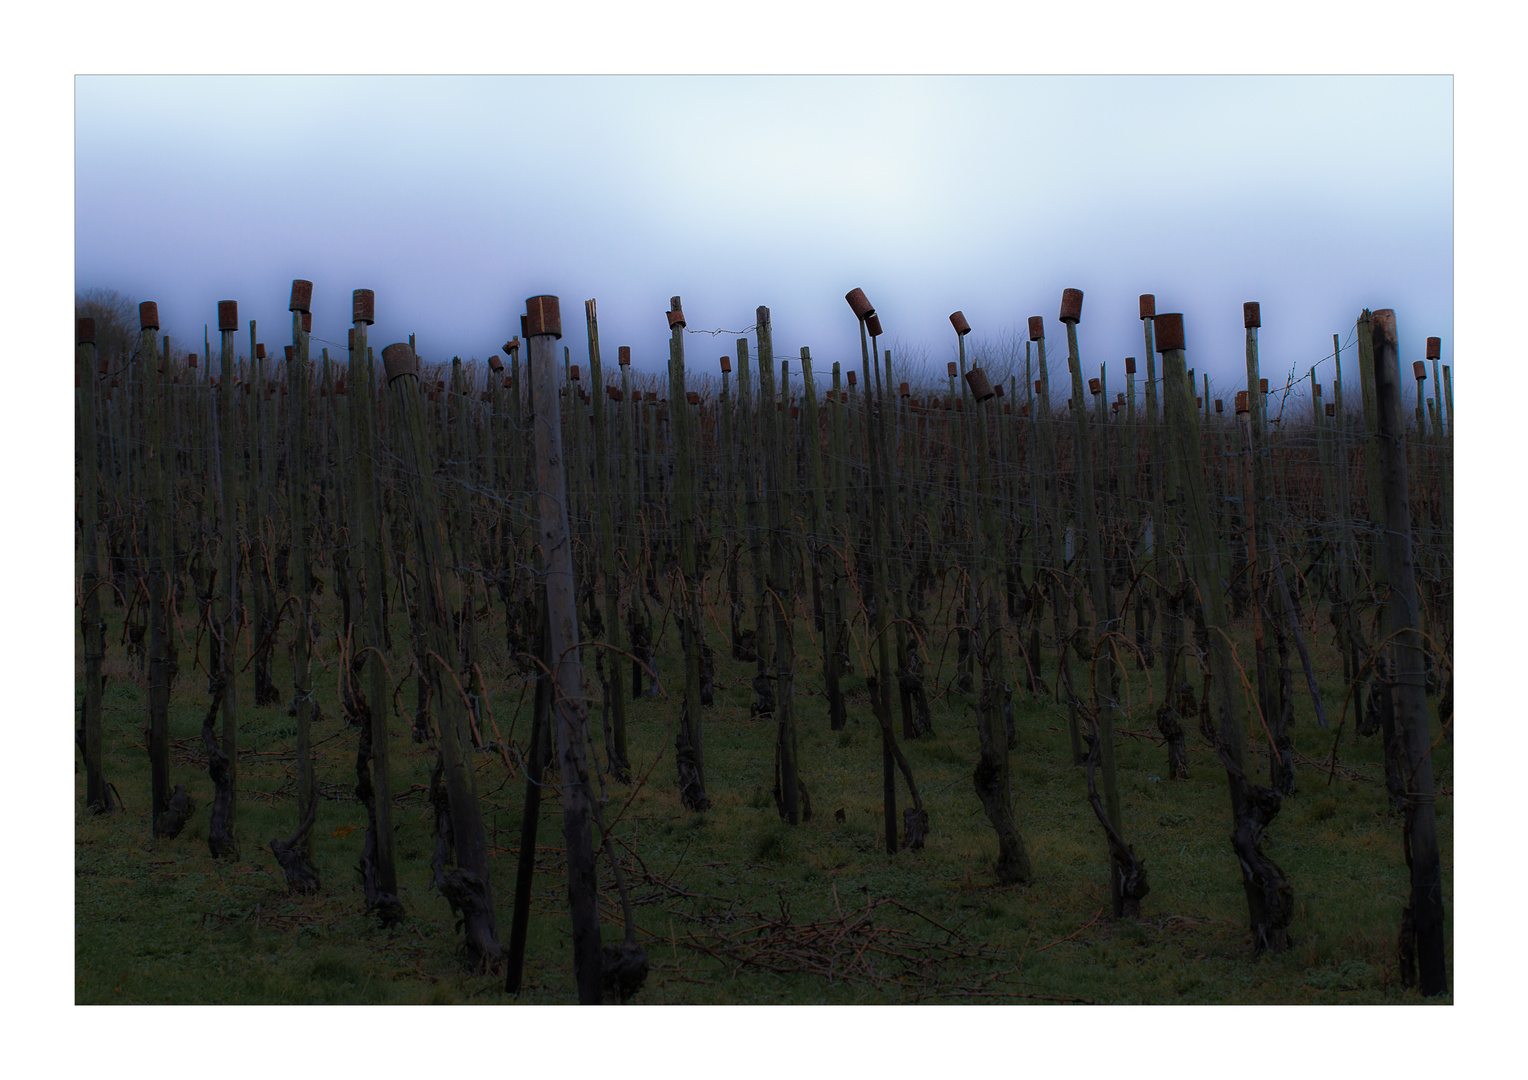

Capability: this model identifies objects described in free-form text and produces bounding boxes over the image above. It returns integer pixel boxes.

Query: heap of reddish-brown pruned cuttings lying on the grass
[654,892,1007,993]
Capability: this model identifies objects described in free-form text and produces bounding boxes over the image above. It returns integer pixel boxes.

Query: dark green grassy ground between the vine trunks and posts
[75,577,1453,1004]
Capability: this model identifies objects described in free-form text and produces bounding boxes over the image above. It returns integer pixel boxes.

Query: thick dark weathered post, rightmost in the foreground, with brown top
[1371,309,1449,998]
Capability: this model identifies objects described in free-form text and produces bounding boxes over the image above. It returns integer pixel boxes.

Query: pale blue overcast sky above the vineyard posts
[75,76,1453,400]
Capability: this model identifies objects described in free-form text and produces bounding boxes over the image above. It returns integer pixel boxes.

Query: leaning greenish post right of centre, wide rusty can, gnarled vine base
[1154,313,1294,953]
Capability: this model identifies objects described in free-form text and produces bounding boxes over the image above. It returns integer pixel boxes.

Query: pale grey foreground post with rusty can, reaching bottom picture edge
[526,296,604,1005]
